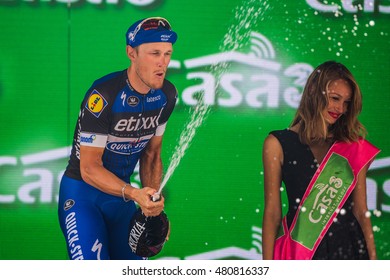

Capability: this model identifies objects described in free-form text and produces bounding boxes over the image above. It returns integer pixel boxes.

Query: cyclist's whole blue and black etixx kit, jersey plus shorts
[58,70,177,259]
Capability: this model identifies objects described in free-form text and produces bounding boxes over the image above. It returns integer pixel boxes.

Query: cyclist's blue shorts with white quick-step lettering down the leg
[58,176,142,260]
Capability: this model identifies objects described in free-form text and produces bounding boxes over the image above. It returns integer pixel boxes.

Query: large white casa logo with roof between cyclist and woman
[169,31,314,109]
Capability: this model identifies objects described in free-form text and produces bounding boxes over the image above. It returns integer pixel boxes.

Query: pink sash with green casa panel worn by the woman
[274,139,380,260]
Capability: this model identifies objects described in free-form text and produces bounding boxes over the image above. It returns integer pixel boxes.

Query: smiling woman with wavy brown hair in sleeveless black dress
[262,61,376,259]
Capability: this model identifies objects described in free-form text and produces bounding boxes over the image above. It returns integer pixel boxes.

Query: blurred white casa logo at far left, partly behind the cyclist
[0,146,141,207]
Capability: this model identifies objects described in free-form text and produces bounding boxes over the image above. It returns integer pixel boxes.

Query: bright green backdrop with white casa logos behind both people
[0,0,390,260]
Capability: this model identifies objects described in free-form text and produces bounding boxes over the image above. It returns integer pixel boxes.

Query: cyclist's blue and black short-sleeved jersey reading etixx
[65,70,177,182]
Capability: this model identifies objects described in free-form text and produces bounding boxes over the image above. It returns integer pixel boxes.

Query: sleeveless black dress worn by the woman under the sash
[270,129,368,260]
